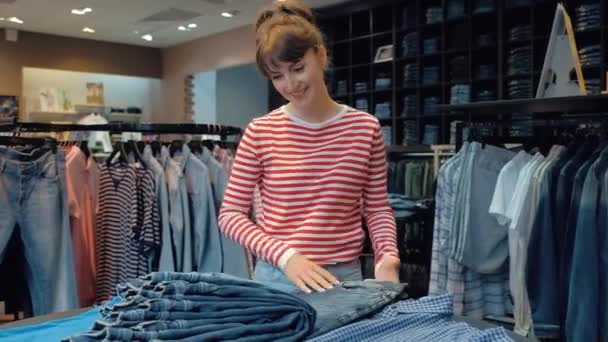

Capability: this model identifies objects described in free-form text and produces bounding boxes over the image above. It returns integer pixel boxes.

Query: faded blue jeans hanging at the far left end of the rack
[0,148,78,315]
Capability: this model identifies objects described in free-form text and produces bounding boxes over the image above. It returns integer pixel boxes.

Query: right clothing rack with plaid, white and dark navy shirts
[429,95,608,341]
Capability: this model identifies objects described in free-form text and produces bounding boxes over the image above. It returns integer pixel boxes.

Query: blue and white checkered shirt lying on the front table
[311,294,513,342]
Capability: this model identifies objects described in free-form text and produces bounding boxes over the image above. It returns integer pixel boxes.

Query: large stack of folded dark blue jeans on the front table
[70,272,318,342]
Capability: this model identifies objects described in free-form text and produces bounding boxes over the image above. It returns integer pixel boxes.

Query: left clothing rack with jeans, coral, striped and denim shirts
[0,122,247,316]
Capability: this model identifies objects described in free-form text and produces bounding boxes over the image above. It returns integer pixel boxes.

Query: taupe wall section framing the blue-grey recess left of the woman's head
[162,26,255,122]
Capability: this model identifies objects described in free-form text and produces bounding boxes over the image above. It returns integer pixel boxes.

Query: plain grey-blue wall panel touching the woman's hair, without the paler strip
[216,64,268,128]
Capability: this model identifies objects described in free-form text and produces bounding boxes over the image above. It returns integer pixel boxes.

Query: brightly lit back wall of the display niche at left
[21,68,163,122]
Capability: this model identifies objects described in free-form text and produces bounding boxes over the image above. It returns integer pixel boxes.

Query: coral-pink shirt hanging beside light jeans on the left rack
[66,146,99,307]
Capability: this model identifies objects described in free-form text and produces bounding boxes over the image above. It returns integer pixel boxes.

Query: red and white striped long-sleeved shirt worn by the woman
[219,106,399,267]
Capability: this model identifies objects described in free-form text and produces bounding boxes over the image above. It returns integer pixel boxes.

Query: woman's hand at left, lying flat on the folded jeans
[284,253,339,293]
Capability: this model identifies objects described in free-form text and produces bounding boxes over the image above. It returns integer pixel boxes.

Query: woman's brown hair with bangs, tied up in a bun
[255,0,324,77]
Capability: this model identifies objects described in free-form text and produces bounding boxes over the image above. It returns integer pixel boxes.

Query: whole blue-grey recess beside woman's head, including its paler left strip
[194,64,268,128]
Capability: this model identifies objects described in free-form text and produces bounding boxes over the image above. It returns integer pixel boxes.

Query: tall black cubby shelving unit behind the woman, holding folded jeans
[269,0,608,145]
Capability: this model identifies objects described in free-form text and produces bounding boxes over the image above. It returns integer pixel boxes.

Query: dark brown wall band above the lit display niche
[0,29,163,95]
